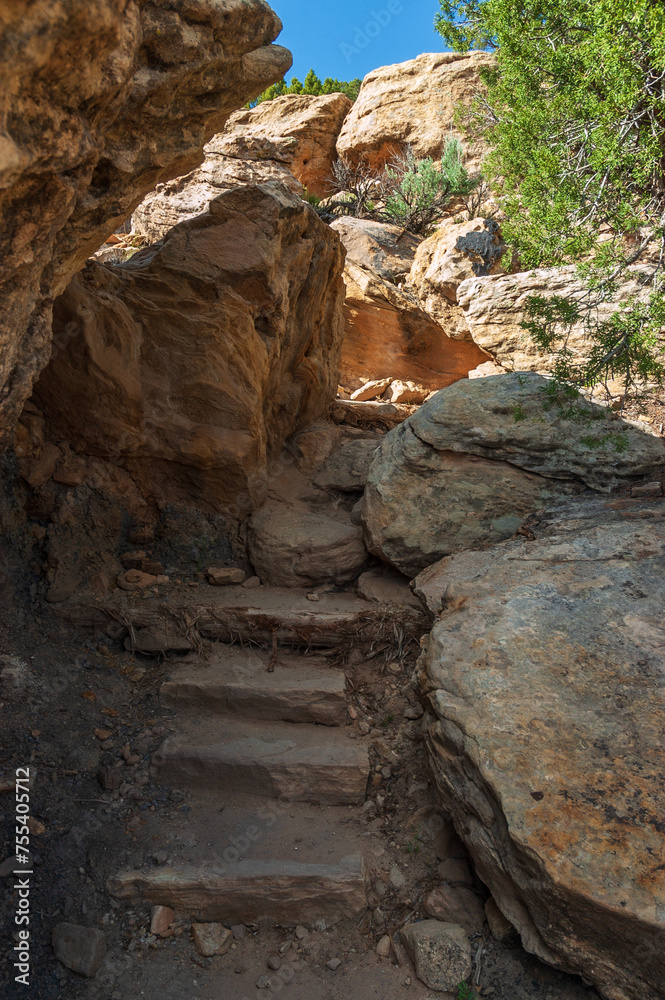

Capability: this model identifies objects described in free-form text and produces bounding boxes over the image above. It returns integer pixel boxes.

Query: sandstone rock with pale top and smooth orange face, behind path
[332,219,487,390]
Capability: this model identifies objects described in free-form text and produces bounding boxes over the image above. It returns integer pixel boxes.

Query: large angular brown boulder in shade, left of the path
[35,184,344,517]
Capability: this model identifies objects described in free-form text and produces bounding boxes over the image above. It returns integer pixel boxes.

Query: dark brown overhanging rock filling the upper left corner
[0,0,291,446]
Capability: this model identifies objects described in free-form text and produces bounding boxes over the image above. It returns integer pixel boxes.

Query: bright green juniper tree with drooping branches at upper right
[436,0,665,398]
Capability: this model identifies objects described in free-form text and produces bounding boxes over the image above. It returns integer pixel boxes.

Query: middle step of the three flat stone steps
[152,718,369,805]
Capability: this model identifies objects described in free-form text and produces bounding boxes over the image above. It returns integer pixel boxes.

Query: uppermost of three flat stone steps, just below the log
[161,646,347,726]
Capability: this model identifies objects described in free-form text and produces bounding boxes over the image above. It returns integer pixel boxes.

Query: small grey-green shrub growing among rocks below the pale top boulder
[386,139,477,233]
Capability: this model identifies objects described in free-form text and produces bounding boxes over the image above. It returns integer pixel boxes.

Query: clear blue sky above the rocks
[269,0,444,81]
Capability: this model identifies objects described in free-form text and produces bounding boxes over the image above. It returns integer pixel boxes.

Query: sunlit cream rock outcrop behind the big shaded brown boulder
[132,94,351,240]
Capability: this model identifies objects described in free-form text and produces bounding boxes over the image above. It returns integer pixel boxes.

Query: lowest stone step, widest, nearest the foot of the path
[108,855,367,926]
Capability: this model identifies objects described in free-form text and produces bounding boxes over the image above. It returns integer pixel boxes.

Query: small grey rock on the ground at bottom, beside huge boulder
[400,920,472,994]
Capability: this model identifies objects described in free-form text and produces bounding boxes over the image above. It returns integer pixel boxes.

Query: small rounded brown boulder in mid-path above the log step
[248,503,367,587]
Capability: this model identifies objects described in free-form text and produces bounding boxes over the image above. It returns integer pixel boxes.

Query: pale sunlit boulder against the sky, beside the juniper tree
[337,52,494,170]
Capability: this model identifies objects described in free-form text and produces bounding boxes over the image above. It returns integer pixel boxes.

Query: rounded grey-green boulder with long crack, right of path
[362,373,665,576]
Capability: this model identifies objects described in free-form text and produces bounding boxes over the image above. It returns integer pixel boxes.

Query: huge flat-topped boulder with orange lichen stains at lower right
[416,498,665,1000]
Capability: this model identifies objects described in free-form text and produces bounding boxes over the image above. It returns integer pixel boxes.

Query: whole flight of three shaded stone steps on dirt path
[109,644,370,925]
